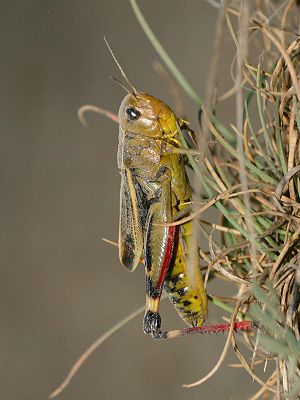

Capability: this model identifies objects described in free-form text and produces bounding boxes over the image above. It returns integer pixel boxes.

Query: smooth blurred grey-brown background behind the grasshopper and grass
[0,0,262,400]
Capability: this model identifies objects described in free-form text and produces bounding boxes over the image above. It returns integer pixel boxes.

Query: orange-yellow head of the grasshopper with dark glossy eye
[119,92,180,139]
